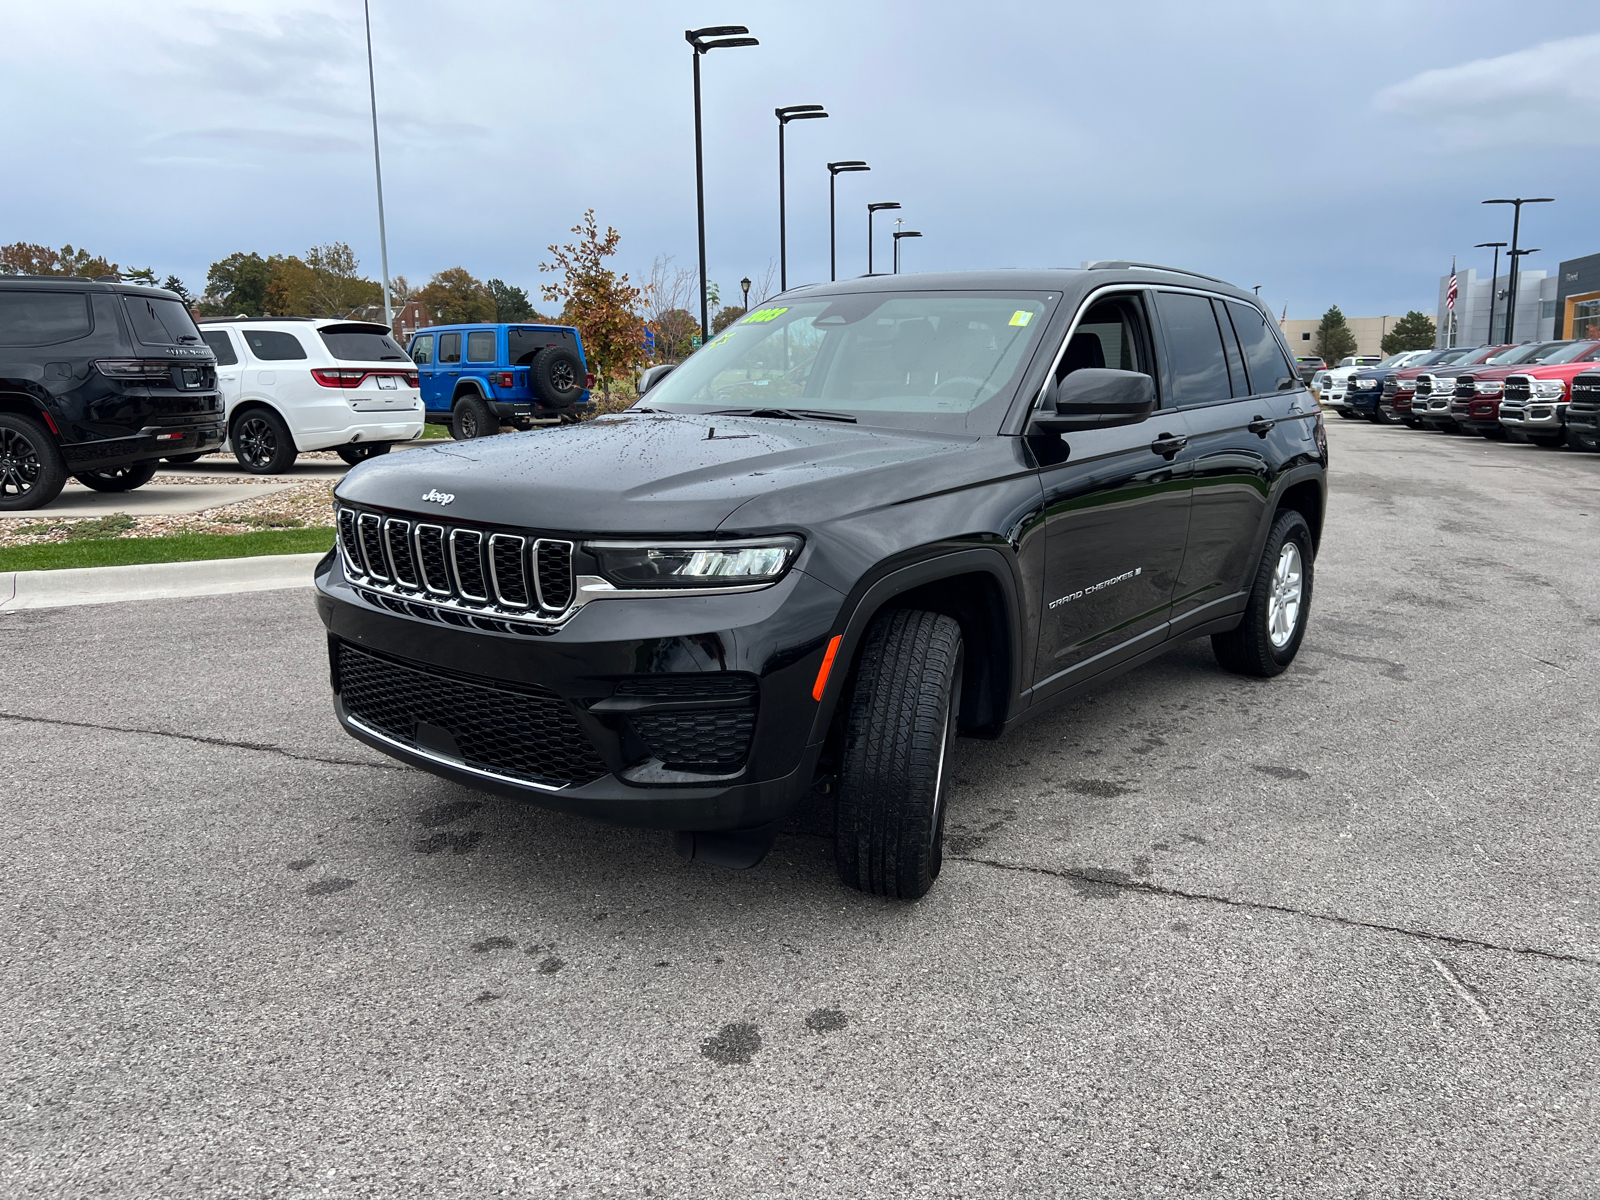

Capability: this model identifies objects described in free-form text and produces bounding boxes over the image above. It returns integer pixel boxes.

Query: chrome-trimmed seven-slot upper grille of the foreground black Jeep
[338,504,576,634]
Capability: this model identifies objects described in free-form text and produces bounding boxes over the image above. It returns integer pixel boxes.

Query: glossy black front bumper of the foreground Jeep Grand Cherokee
[315,555,843,830]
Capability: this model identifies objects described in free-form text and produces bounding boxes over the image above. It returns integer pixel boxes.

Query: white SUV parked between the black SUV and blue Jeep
[184,317,424,475]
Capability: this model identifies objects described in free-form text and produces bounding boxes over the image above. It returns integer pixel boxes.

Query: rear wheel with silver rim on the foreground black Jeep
[1211,510,1312,678]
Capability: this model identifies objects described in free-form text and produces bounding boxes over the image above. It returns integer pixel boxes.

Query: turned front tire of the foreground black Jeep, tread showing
[834,610,963,899]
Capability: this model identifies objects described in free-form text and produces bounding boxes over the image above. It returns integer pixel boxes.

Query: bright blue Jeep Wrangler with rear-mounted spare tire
[411,325,594,442]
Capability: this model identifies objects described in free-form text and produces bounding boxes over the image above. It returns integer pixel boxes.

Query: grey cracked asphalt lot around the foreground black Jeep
[0,421,1600,1200]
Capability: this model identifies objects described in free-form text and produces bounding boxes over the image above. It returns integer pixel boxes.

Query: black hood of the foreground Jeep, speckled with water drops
[336,413,992,534]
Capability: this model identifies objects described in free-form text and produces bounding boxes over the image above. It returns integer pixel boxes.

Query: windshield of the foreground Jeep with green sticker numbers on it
[642,291,1058,427]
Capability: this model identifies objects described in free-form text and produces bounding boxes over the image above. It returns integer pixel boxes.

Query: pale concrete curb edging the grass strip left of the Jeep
[0,554,323,613]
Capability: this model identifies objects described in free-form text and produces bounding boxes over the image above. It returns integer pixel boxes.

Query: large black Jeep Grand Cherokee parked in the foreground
[317,262,1326,898]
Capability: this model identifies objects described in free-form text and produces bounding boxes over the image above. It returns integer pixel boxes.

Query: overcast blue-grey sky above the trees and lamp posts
[0,0,1600,317]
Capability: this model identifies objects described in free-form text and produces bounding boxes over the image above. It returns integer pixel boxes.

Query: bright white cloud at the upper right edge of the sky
[1373,34,1600,150]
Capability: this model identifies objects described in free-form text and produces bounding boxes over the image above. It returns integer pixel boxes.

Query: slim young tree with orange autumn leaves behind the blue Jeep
[539,208,645,398]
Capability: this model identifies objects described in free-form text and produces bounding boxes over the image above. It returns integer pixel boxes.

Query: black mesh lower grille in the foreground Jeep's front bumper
[336,642,604,786]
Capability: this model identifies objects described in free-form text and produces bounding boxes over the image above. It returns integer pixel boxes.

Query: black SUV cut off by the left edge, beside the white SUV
[0,275,222,510]
